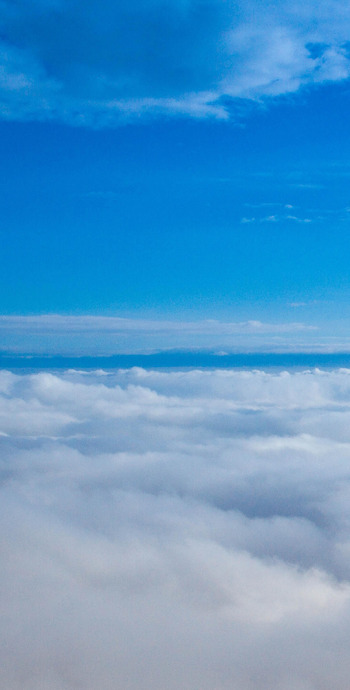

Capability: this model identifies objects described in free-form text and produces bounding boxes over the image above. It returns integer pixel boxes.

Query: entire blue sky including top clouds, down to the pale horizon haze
[0,0,350,349]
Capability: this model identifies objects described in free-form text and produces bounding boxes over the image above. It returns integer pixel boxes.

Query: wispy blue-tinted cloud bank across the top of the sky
[0,0,350,126]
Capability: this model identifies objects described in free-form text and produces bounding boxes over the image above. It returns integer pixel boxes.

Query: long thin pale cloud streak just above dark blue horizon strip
[0,314,317,355]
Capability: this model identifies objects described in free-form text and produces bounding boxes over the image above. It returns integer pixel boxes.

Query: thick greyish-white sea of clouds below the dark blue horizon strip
[0,368,350,690]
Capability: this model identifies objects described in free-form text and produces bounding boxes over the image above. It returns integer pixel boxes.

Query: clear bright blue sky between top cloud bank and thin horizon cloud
[0,85,350,318]
